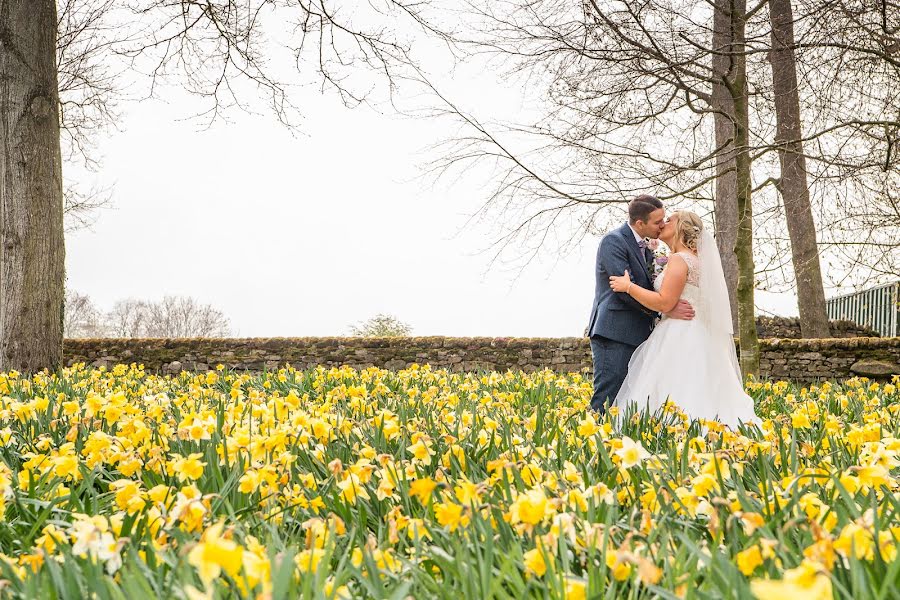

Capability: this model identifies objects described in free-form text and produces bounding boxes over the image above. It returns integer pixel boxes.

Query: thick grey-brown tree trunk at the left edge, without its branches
[0,0,65,372]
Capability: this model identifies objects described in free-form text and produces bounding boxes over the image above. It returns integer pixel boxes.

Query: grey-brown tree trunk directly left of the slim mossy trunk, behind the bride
[711,0,738,331]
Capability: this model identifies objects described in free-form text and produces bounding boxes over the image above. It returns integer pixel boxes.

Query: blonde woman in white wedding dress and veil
[609,210,760,429]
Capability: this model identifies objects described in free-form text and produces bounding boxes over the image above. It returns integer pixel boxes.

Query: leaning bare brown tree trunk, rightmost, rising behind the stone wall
[769,0,831,338]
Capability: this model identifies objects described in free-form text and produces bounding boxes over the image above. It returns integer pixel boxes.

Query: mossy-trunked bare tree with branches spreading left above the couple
[428,0,761,373]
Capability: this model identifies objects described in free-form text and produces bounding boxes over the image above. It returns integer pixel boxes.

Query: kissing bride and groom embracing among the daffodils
[587,195,760,429]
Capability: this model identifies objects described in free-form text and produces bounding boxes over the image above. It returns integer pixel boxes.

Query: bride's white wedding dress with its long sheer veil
[613,231,760,429]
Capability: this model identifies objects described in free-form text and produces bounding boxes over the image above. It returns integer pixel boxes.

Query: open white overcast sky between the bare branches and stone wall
[67,35,796,337]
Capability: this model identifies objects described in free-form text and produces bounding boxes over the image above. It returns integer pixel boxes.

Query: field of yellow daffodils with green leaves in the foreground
[0,365,900,600]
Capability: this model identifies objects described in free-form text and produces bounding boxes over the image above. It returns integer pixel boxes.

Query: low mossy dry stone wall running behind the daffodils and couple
[64,337,900,381]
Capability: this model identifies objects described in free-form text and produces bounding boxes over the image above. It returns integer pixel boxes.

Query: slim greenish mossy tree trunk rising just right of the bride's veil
[725,0,759,376]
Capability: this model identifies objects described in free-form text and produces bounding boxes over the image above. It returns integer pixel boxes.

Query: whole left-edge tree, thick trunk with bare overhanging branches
[0,0,437,372]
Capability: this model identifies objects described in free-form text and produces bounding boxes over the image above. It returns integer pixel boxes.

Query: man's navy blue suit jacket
[588,223,657,346]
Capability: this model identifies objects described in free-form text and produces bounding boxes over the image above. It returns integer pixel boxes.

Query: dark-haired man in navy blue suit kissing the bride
[587,195,694,414]
